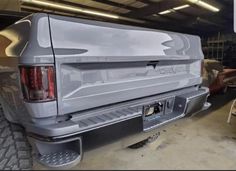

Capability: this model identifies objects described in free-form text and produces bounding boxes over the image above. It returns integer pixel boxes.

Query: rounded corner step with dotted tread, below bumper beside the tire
[29,137,83,169]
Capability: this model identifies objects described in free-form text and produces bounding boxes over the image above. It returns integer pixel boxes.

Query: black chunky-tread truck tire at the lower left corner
[0,106,33,170]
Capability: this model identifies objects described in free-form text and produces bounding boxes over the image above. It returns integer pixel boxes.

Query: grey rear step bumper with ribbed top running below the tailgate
[25,88,209,139]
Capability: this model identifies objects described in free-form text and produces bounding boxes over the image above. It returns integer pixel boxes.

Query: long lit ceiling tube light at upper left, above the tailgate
[21,0,119,19]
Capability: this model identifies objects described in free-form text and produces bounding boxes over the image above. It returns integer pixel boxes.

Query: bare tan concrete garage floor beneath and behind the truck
[34,90,236,170]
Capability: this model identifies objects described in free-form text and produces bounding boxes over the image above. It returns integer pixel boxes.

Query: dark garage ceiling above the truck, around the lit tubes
[0,0,233,35]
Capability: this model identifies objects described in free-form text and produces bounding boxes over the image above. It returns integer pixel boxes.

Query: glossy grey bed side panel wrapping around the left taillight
[0,13,57,122]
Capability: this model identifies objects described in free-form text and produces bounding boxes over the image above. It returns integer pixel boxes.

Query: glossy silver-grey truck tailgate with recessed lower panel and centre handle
[50,15,203,114]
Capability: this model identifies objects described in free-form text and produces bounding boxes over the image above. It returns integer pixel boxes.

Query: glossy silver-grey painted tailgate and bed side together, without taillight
[0,14,203,122]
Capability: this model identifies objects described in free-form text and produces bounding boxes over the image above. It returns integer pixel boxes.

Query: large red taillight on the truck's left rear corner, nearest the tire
[20,66,55,101]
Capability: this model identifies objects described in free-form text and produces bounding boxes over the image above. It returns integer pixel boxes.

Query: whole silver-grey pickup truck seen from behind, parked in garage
[0,13,209,169]
